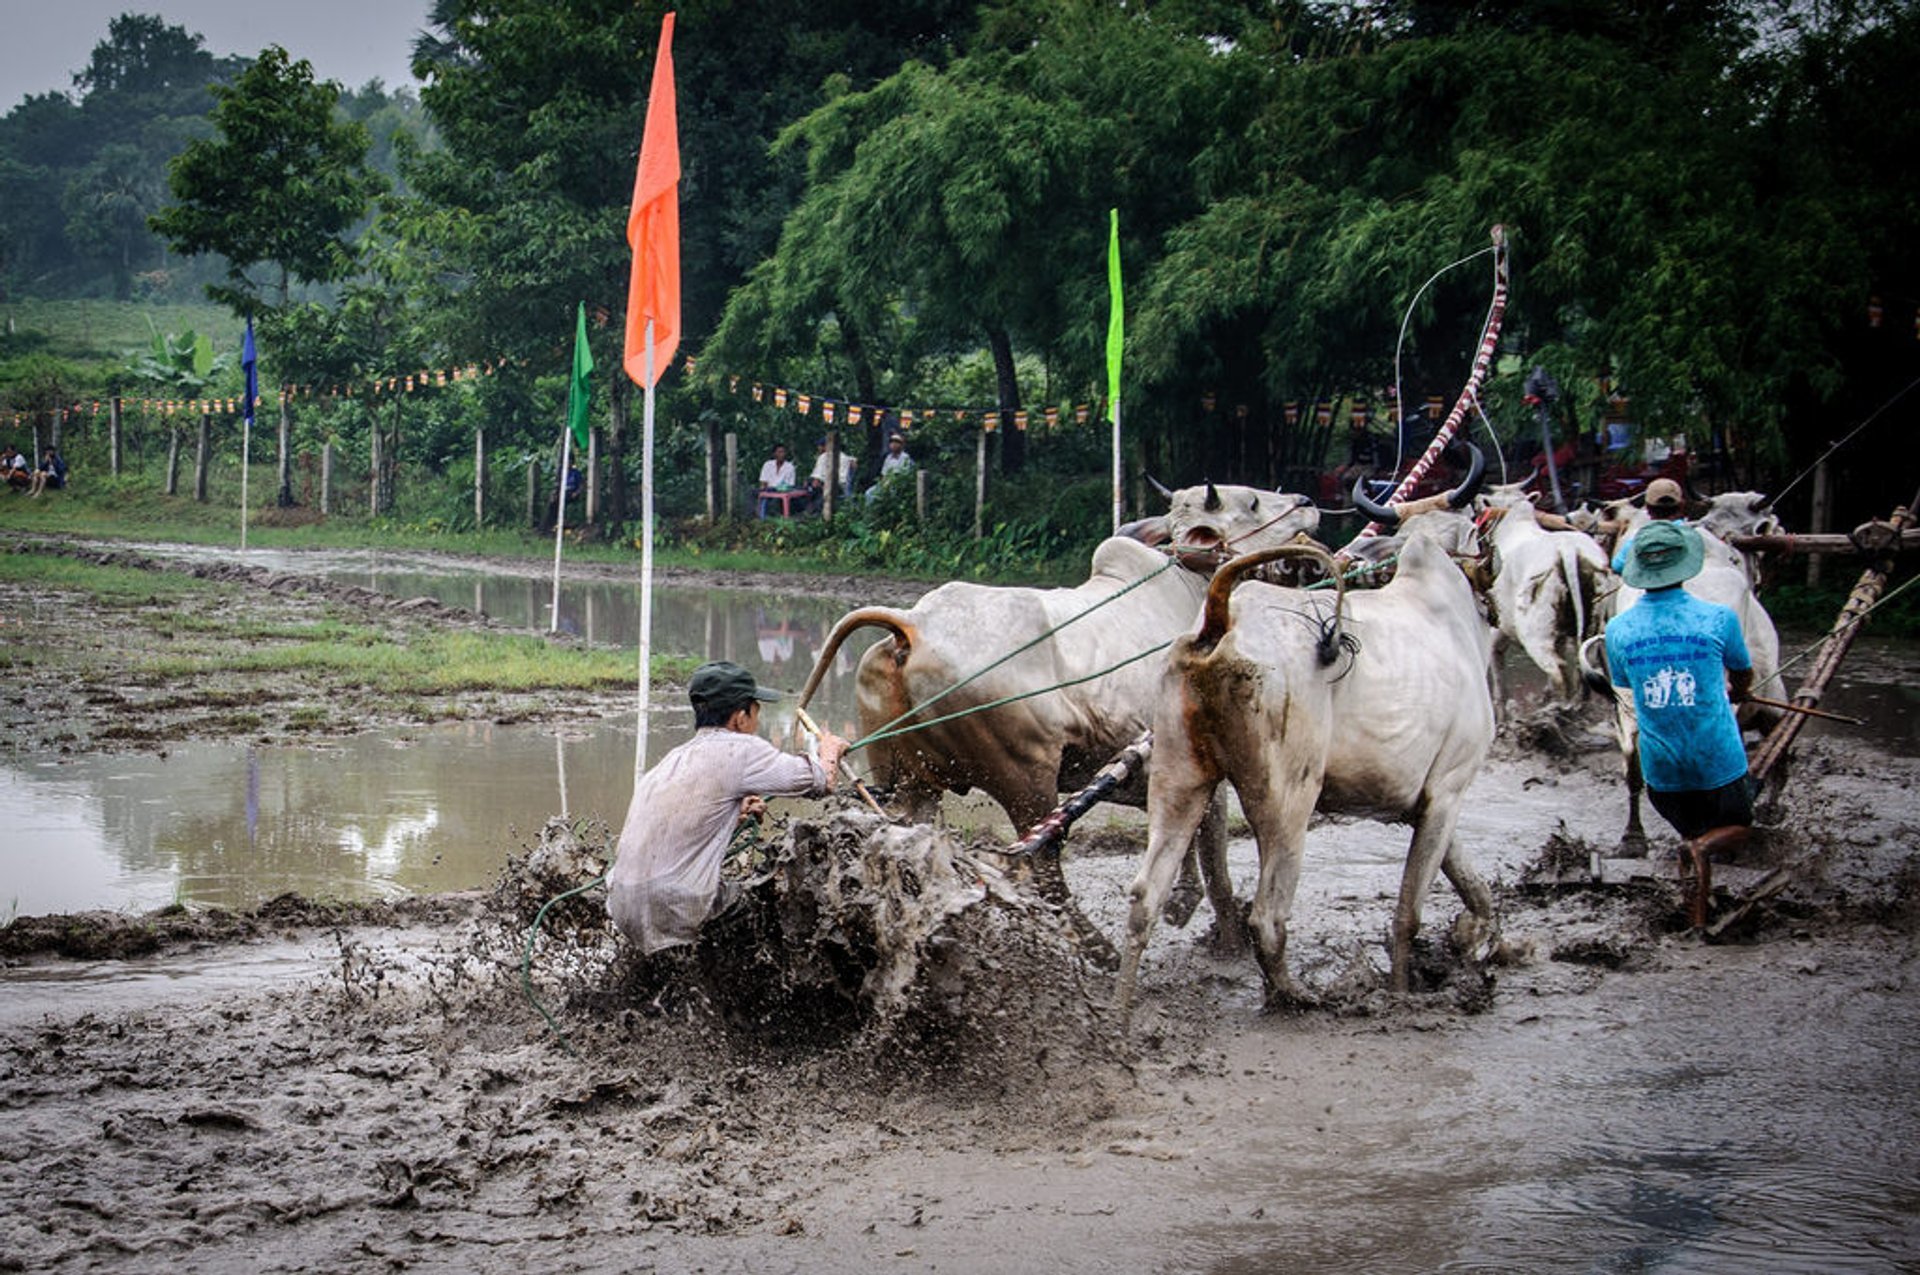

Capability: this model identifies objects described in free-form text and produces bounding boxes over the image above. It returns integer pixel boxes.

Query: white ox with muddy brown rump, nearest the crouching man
[801,484,1319,931]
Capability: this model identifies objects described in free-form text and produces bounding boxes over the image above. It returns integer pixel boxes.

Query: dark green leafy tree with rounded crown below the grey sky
[150,44,386,311]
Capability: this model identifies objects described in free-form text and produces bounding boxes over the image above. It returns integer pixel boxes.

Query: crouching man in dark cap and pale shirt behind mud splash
[607,661,847,956]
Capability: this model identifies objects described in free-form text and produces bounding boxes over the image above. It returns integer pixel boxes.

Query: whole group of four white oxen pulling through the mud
[801,453,1784,1006]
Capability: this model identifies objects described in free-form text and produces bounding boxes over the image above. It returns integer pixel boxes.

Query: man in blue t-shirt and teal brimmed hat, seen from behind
[1607,522,1753,927]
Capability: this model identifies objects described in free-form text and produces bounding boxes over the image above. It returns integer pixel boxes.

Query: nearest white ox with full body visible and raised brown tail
[1121,536,1494,1006]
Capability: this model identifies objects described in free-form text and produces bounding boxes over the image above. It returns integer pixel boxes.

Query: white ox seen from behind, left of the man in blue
[1482,484,1607,703]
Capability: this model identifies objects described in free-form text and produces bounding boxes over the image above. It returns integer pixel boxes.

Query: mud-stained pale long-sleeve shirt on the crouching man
[607,726,828,954]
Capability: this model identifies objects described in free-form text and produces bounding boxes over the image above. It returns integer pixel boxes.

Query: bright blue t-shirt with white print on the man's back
[1607,588,1753,793]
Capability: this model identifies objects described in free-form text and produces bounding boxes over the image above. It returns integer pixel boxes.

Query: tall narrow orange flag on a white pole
[622,13,680,386]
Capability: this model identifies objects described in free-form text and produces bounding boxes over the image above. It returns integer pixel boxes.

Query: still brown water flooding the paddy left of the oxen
[0,545,875,918]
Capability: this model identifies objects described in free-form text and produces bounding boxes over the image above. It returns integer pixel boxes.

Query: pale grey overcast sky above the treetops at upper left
[0,0,428,106]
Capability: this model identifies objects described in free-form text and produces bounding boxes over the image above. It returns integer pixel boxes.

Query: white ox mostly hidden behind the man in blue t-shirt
[1580,492,1789,851]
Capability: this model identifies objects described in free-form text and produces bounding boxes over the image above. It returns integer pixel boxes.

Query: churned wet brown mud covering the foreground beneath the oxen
[0,541,1920,1275]
